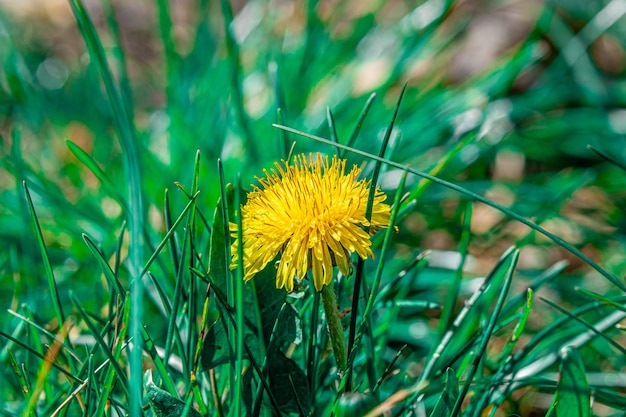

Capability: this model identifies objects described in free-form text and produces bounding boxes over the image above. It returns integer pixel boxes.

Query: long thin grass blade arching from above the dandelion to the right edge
[273,124,626,292]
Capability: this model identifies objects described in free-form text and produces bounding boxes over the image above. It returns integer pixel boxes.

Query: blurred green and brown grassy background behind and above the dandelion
[0,0,626,412]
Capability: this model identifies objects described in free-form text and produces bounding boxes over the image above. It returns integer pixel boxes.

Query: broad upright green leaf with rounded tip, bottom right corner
[555,346,591,417]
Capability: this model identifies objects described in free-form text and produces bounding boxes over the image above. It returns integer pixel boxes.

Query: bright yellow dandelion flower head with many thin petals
[230,154,390,291]
